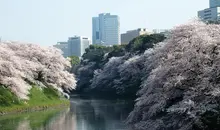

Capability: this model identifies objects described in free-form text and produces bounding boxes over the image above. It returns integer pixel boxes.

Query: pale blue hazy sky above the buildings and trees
[0,0,209,46]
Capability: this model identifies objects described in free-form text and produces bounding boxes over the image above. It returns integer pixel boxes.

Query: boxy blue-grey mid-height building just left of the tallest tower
[68,36,91,57]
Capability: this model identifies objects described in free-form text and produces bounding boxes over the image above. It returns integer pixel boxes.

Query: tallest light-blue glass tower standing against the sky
[92,13,121,46]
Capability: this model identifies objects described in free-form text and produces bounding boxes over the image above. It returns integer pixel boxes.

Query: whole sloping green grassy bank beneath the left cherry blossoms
[0,86,69,115]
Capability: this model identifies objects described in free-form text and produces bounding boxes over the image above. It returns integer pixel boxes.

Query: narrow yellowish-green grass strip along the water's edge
[0,100,70,116]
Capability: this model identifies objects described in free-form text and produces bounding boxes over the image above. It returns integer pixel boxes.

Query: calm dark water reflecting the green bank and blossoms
[0,96,133,130]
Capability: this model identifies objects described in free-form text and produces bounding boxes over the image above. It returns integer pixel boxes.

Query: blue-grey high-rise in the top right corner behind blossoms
[198,0,220,21]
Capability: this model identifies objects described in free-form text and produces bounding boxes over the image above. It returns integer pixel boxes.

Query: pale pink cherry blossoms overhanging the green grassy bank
[0,42,76,99]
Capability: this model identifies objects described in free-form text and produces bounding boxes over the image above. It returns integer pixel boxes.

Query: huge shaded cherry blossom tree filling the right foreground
[127,20,220,130]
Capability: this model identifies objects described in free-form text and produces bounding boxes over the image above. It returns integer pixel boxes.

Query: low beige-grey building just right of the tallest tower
[121,28,150,44]
